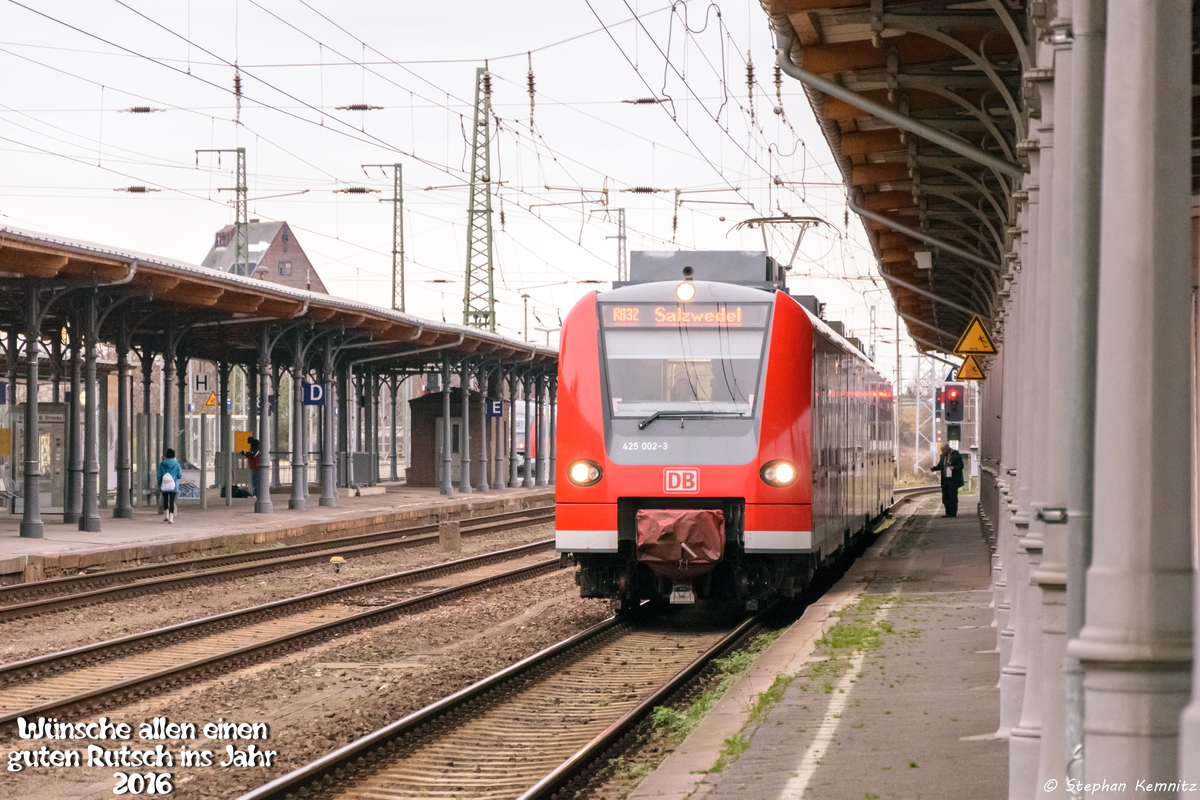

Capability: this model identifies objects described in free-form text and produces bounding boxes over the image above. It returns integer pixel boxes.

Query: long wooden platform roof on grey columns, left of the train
[0,227,558,368]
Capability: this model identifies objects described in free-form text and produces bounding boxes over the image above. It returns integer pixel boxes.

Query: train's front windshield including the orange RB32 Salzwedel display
[600,303,769,417]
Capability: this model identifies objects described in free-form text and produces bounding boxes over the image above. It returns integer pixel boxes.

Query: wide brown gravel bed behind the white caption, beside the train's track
[0,570,608,800]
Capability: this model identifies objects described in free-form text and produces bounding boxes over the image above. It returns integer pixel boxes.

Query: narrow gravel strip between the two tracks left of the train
[0,523,554,663]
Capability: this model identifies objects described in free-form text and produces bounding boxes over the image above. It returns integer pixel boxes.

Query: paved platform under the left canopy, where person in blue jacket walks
[0,482,554,585]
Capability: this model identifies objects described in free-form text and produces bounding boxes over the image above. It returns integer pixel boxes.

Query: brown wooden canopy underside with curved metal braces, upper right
[764,0,1027,353]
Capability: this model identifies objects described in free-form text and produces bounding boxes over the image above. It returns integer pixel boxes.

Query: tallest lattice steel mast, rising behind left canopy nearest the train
[462,67,496,331]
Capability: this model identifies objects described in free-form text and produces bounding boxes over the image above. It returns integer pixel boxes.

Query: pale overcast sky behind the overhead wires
[0,0,926,381]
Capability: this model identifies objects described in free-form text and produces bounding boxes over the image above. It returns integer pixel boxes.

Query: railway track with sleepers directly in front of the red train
[241,609,758,800]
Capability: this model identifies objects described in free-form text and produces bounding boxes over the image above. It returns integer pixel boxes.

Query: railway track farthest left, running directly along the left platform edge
[0,506,554,621]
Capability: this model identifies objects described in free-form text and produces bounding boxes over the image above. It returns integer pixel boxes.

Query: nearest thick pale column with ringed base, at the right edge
[1068,0,1196,798]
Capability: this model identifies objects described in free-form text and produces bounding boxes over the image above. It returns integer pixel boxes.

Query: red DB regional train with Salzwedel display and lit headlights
[556,251,895,609]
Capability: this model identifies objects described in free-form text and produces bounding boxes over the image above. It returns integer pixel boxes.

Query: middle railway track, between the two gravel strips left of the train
[0,540,560,724]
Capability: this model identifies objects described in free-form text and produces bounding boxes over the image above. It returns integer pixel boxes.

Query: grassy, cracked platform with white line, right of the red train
[629,495,1008,800]
